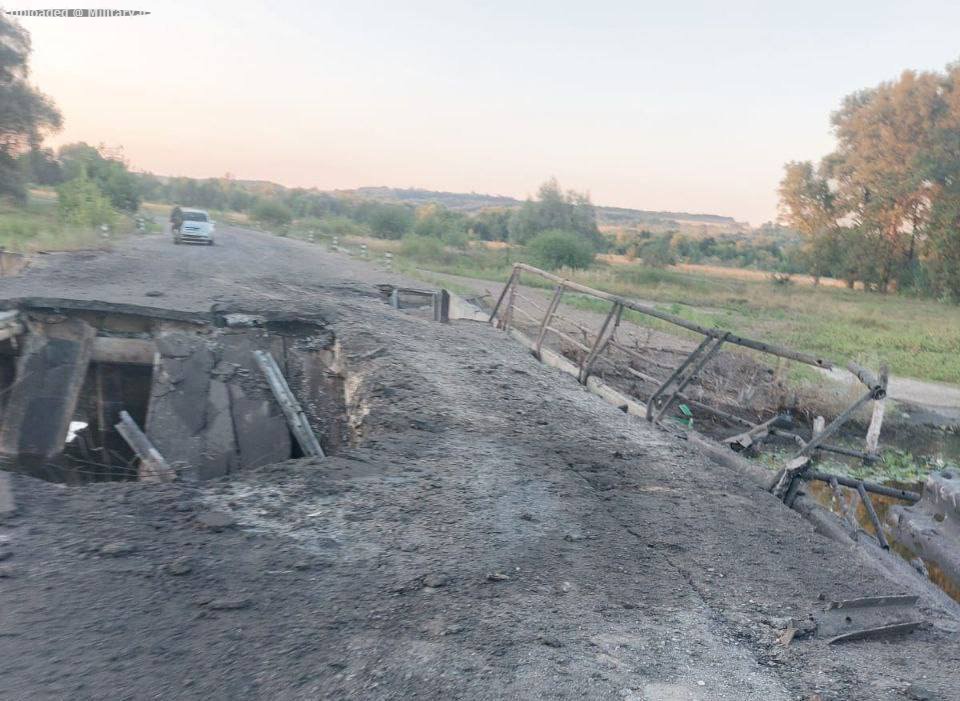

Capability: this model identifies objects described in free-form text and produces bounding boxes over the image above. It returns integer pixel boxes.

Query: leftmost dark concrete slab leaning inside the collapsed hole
[0,319,96,474]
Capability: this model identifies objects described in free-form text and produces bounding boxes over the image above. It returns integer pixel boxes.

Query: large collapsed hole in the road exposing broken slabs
[0,300,350,483]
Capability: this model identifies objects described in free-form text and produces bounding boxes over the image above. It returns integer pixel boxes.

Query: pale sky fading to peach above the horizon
[7,0,960,225]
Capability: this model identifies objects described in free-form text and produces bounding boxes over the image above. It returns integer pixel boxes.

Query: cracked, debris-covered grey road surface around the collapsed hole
[0,229,960,700]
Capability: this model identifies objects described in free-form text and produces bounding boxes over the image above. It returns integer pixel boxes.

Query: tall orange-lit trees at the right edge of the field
[779,63,960,302]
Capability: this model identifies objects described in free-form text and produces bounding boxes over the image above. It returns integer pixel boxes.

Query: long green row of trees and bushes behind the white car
[0,6,606,267]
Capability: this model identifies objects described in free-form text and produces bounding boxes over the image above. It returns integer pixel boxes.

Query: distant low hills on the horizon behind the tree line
[333,187,746,231]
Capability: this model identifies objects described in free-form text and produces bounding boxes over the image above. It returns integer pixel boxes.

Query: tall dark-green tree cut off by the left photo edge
[0,12,61,201]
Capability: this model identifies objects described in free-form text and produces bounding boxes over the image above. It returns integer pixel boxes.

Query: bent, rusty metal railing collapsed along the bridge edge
[490,263,920,548]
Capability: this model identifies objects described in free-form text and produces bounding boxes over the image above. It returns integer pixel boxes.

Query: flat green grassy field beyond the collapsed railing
[392,250,960,384]
